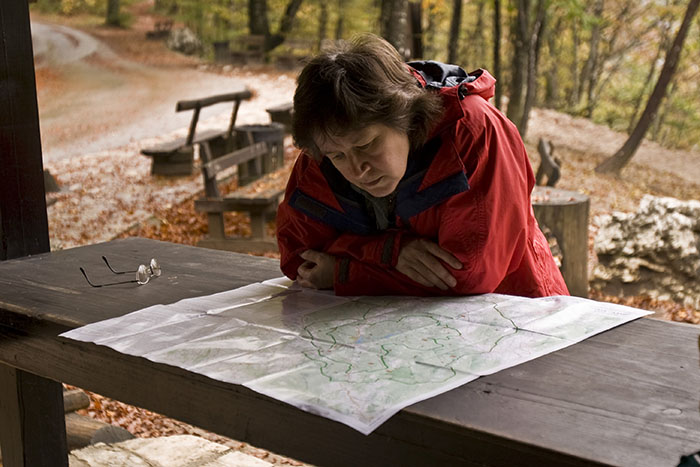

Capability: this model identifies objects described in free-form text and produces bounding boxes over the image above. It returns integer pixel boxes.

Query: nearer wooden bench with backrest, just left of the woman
[194,141,284,253]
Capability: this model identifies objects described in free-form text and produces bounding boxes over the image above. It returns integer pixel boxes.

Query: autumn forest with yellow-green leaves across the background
[35,0,700,160]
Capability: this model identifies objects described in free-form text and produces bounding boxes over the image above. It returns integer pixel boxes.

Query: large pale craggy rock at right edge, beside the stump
[590,195,700,309]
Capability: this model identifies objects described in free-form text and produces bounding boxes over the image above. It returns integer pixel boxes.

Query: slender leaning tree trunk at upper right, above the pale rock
[595,0,700,174]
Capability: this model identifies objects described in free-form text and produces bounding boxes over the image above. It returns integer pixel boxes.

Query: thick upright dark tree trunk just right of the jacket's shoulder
[507,0,530,128]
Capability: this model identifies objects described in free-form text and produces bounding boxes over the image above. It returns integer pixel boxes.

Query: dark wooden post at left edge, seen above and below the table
[0,0,68,467]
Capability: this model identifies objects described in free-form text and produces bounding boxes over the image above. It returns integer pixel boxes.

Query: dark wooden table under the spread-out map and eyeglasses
[0,239,700,467]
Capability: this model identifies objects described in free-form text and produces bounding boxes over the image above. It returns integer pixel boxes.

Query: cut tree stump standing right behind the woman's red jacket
[532,186,590,297]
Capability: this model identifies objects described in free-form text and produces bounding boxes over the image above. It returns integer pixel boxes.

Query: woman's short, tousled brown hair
[292,34,442,160]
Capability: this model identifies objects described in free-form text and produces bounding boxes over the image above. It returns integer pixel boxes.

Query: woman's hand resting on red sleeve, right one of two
[396,238,462,290]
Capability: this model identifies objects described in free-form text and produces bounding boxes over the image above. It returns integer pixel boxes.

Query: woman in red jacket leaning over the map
[277,35,568,297]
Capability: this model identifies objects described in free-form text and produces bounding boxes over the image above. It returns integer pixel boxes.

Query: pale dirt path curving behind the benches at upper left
[32,21,254,161]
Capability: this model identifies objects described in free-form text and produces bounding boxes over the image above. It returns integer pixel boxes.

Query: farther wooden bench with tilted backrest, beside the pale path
[141,89,252,175]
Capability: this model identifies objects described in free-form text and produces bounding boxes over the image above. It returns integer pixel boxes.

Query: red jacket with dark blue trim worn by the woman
[277,65,568,297]
